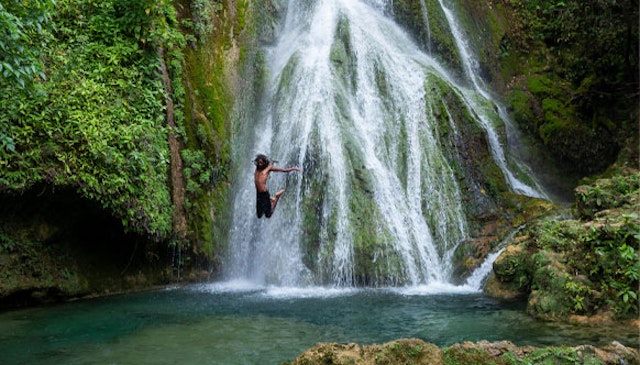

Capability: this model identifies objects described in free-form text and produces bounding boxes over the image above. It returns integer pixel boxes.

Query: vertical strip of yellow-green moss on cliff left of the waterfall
[181,1,253,259]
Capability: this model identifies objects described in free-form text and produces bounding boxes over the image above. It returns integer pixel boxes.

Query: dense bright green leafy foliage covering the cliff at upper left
[0,0,189,236]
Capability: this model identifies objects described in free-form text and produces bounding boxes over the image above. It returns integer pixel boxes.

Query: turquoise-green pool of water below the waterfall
[0,282,638,365]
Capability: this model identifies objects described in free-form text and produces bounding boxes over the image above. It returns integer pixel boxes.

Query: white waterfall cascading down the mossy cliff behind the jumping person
[225,0,536,287]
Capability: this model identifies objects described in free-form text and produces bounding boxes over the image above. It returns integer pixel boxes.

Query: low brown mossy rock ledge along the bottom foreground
[284,339,640,365]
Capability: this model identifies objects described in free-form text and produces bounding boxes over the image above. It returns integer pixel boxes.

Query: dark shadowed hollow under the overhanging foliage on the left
[0,186,173,307]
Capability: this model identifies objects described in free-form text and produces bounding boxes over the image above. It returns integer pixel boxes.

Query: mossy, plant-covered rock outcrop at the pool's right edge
[486,172,640,319]
